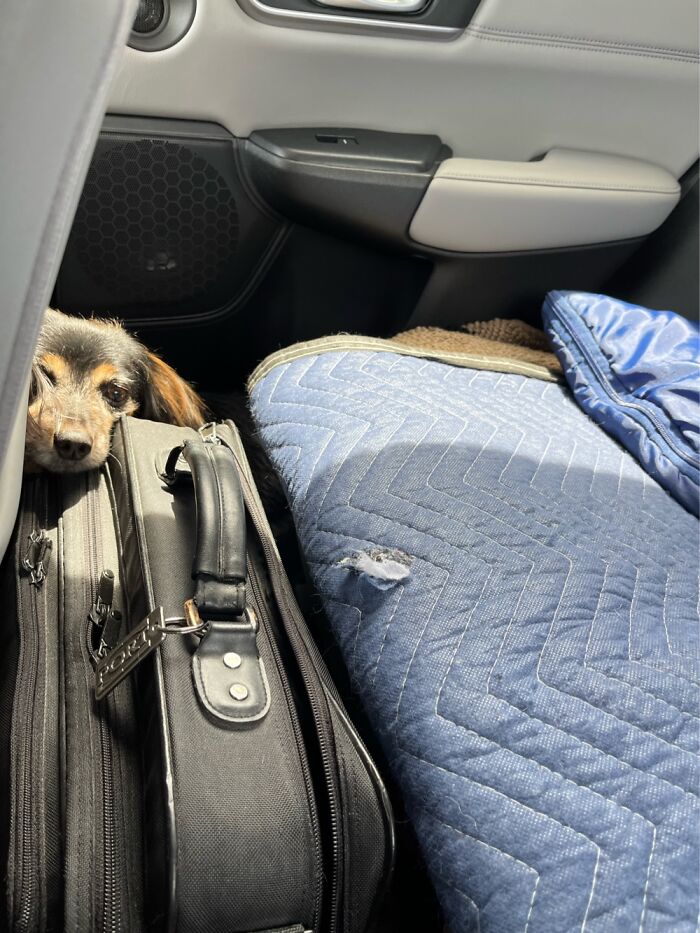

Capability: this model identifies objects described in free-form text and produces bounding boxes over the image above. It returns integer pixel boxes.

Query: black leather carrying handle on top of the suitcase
[164,440,246,620]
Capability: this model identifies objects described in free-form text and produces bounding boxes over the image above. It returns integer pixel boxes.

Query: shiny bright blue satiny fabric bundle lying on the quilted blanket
[542,291,700,515]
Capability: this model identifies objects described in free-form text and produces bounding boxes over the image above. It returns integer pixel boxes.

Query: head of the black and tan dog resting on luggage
[25,309,206,473]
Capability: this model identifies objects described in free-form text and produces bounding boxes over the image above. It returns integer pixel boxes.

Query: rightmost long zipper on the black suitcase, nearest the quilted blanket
[202,425,344,933]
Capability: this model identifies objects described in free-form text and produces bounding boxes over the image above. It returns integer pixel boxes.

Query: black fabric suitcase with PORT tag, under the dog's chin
[0,418,393,933]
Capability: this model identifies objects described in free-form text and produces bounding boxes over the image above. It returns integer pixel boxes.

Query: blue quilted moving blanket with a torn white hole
[252,351,700,933]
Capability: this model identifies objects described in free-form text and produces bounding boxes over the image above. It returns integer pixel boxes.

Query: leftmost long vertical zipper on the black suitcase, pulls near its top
[8,478,58,933]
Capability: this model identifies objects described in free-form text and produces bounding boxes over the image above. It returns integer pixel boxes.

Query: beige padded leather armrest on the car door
[410,149,680,252]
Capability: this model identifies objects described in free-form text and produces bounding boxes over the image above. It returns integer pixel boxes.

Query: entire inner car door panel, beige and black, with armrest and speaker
[56,0,698,379]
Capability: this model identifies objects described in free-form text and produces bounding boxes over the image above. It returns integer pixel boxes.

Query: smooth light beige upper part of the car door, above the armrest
[110,0,698,178]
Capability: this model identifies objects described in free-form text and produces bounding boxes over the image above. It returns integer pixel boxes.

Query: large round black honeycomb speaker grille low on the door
[72,139,239,304]
